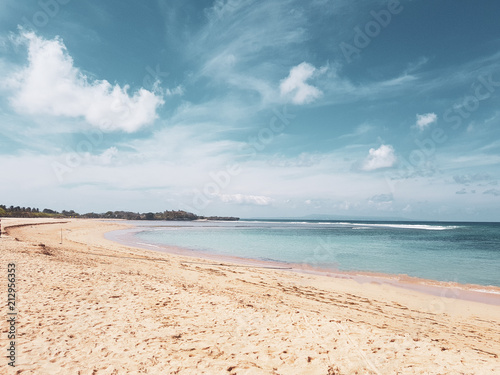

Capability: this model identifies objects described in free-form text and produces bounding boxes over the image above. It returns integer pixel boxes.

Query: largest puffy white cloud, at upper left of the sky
[8,32,163,132]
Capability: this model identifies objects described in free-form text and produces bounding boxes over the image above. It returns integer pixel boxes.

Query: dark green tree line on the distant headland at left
[0,205,239,221]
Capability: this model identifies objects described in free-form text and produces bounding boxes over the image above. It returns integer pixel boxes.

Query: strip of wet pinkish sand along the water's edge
[104,224,500,306]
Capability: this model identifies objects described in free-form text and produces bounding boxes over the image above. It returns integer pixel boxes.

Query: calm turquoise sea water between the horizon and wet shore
[130,221,500,286]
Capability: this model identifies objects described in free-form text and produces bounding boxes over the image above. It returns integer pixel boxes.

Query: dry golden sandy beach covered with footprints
[0,219,500,375]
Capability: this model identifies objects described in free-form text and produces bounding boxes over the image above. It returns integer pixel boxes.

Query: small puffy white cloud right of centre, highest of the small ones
[280,62,323,104]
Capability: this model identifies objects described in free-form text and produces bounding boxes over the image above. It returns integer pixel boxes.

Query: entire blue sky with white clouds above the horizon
[0,0,500,221]
